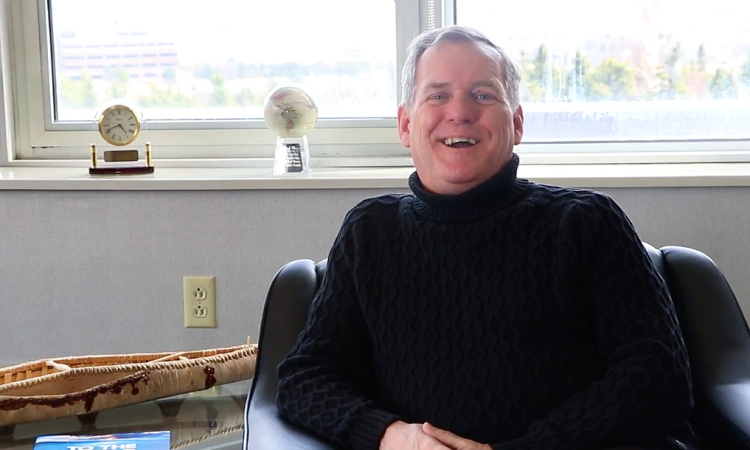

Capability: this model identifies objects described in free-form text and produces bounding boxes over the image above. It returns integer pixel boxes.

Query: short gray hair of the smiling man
[401,25,521,111]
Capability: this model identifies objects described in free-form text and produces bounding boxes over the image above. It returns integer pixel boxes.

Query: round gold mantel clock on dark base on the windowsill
[89,102,154,175]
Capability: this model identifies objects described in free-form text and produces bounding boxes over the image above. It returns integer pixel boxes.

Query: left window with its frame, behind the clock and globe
[2,0,408,159]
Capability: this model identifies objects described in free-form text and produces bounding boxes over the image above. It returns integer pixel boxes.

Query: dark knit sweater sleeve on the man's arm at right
[492,194,693,450]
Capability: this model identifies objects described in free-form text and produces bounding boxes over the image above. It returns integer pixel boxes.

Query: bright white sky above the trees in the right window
[456,0,750,60]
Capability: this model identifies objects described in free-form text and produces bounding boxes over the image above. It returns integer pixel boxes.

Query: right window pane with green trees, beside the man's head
[456,0,750,142]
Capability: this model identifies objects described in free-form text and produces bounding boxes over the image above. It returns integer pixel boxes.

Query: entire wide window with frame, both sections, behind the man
[0,0,750,166]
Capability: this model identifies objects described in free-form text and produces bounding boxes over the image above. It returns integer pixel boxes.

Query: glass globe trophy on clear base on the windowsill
[263,86,318,175]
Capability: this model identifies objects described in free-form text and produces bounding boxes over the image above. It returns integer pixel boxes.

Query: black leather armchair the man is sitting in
[243,244,750,450]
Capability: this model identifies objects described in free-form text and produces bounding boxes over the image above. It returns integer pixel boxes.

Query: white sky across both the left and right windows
[52,0,750,64]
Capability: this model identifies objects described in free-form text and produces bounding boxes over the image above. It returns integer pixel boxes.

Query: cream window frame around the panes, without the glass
[0,0,750,167]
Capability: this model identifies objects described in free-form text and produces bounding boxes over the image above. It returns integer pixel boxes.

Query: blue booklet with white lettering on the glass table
[34,431,169,450]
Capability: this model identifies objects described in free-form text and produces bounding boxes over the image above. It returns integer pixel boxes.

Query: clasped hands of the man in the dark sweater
[380,421,492,450]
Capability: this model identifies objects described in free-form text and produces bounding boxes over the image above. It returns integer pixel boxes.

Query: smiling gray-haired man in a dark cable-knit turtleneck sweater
[278,27,698,450]
